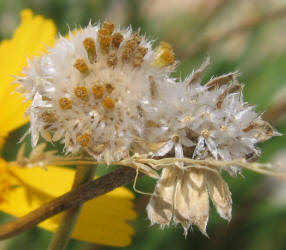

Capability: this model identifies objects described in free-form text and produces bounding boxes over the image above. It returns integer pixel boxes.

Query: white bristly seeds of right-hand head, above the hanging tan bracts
[149,60,279,175]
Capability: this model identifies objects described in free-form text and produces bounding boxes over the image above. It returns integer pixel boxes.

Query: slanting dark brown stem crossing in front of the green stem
[0,167,139,240]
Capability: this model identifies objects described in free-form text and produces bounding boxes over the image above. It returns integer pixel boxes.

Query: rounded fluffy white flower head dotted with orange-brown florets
[19,22,174,163]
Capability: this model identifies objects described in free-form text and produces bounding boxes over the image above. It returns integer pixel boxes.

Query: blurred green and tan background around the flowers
[0,0,286,250]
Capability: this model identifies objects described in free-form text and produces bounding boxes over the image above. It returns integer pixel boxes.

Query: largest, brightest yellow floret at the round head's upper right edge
[152,42,175,67]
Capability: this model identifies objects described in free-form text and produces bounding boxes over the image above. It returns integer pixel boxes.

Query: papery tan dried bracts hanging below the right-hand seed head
[147,166,232,235]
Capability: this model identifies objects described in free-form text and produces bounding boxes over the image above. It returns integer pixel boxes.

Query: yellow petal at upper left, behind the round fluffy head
[0,10,56,138]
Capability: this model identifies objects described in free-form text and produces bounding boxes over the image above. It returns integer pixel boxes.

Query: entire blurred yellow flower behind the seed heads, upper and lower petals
[0,10,136,246]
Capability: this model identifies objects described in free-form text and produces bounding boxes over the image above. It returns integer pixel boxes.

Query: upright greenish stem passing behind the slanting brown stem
[48,165,96,250]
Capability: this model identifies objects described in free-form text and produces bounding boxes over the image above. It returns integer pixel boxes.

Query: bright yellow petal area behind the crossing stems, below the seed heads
[0,162,136,246]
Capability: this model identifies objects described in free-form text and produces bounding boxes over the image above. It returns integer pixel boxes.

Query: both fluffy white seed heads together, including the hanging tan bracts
[19,21,277,233]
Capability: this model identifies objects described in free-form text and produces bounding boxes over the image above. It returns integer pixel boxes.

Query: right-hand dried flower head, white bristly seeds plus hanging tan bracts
[146,60,278,234]
